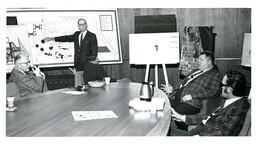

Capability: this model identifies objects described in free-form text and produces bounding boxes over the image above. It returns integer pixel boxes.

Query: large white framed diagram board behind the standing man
[7,10,122,66]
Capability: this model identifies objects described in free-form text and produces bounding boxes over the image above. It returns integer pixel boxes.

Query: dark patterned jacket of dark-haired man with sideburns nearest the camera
[189,97,249,136]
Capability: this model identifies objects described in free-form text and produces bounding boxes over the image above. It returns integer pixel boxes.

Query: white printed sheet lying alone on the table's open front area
[72,111,118,121]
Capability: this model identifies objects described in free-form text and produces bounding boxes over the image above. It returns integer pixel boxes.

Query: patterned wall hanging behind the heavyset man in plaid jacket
[179,26,215,78]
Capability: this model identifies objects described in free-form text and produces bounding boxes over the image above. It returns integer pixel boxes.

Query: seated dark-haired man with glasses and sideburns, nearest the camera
[171,71,249,136]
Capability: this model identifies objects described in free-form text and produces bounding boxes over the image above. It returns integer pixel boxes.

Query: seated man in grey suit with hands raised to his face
[9,53,48,97]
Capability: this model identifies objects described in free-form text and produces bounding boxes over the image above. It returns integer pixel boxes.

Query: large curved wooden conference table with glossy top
[6,82,170,137]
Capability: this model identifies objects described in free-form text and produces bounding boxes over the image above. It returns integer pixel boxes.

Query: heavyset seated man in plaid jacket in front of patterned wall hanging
[162,51,221,130]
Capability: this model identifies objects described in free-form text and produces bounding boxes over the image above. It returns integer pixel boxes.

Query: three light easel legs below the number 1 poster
[144,64,169,88]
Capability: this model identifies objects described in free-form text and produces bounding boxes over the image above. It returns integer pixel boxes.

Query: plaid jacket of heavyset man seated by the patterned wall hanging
[178,67,221,108]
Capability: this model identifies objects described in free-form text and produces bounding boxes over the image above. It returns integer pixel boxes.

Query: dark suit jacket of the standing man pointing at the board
[55,30,98,71]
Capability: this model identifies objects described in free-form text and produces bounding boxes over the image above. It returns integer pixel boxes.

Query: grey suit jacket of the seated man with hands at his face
[9,68,48,97]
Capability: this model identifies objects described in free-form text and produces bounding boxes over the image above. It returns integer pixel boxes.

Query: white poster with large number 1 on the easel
[129,32,180,65]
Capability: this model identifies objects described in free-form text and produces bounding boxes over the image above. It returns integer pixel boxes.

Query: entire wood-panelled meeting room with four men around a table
[5,7,252,137]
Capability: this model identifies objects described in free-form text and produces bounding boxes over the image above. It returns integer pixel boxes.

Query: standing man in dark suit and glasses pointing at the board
[43,18,98,86]
